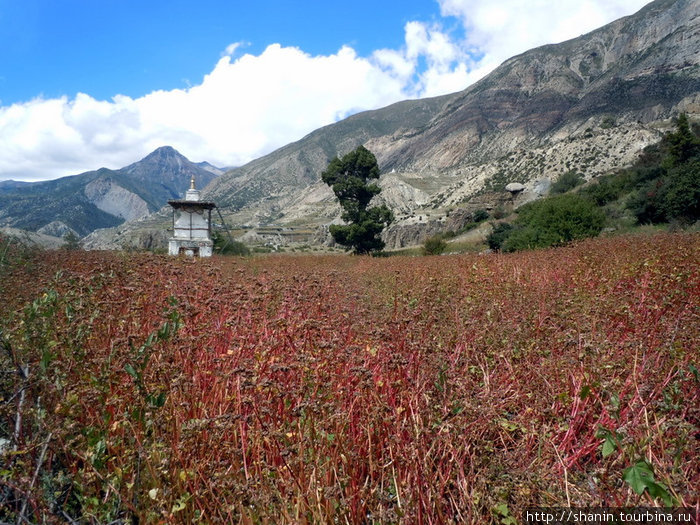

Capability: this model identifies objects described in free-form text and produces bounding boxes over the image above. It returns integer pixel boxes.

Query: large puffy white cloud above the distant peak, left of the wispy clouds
[0,44,410,180]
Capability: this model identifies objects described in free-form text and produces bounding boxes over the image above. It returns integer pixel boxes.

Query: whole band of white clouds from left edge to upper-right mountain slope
[0,0,646,180]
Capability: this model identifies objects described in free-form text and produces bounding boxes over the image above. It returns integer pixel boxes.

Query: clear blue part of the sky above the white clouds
[0,0,448,105]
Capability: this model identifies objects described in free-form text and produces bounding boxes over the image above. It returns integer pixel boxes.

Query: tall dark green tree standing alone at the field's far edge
[321,146,394,254]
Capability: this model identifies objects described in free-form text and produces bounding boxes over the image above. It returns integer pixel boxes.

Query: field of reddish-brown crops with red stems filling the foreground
[0,234,700,525]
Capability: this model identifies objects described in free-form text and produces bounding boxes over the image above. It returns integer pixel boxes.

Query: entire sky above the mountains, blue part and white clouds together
[0,0,646,180]
